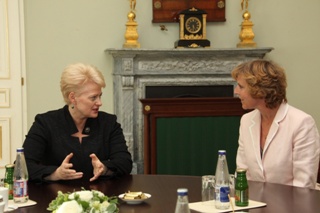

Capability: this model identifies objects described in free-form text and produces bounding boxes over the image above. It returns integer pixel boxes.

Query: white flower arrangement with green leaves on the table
[47,189,119,213]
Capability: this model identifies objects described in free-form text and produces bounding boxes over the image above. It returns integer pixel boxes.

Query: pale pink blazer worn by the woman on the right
[237,103,320,188]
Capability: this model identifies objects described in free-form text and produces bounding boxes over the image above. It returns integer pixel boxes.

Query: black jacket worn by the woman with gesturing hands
[23,106,132,181]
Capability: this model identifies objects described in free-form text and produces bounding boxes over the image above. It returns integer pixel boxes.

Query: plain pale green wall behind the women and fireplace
[24,0,320,127]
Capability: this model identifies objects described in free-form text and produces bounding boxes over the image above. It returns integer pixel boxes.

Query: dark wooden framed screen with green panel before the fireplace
[140,97,246,175]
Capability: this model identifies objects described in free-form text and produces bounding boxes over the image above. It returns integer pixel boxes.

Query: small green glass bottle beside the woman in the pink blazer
[234,169,249,206]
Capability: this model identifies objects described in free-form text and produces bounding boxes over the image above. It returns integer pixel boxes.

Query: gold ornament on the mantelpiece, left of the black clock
[123,0,140,48]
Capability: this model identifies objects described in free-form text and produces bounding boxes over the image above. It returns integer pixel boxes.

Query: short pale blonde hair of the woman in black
[60,63,106,104]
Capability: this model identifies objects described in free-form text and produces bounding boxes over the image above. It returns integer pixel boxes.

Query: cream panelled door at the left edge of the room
[0,0,26,177]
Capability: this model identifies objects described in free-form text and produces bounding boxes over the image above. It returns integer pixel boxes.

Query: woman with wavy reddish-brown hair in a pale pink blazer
[231,59,320,188]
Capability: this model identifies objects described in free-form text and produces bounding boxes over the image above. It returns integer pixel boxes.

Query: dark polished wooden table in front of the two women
[10,175,320,213]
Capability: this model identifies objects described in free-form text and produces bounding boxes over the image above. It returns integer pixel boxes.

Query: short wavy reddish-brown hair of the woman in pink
[231,59,287,109]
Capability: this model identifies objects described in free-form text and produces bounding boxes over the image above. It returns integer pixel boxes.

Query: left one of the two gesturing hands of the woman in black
[46,153,83,180]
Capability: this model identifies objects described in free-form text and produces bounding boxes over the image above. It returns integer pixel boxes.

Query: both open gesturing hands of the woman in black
[46,153,106,181]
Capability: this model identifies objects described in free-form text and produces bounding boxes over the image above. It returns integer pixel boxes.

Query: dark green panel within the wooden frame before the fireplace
[156,116,240,176]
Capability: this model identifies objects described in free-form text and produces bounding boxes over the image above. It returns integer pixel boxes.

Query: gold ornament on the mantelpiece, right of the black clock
[237,0,257,48]
